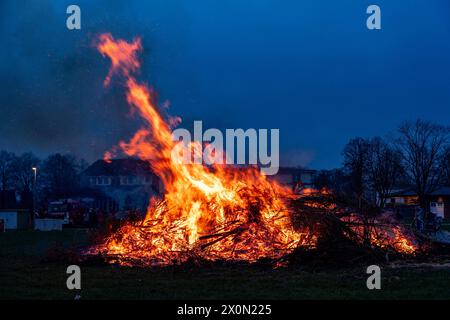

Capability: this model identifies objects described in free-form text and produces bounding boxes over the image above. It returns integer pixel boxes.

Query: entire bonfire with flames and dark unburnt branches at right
[82,34,417,266]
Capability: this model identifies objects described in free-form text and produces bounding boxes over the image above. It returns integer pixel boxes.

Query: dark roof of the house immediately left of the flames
[83,158,153,176]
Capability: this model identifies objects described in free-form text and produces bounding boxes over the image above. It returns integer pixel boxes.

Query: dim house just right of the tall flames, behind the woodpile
[268,167,316,189]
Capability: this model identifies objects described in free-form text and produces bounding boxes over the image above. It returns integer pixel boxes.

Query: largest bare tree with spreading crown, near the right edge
[396,120,450,209]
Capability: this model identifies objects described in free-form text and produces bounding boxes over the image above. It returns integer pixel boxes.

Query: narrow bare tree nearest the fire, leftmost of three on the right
[342,138,369,208]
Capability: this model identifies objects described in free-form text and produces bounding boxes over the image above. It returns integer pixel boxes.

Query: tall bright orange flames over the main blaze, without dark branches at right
[97,34,315,265]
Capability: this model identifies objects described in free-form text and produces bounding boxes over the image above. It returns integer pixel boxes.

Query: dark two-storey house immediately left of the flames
[81,158,163,212]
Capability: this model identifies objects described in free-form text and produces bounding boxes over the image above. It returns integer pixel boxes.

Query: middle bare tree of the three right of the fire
[367,137,403,208]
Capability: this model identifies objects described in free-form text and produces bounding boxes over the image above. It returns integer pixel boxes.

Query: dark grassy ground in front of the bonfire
[0,229,450,299]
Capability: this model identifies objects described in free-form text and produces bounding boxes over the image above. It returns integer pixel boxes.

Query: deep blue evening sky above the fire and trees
[0,0,450,168]
